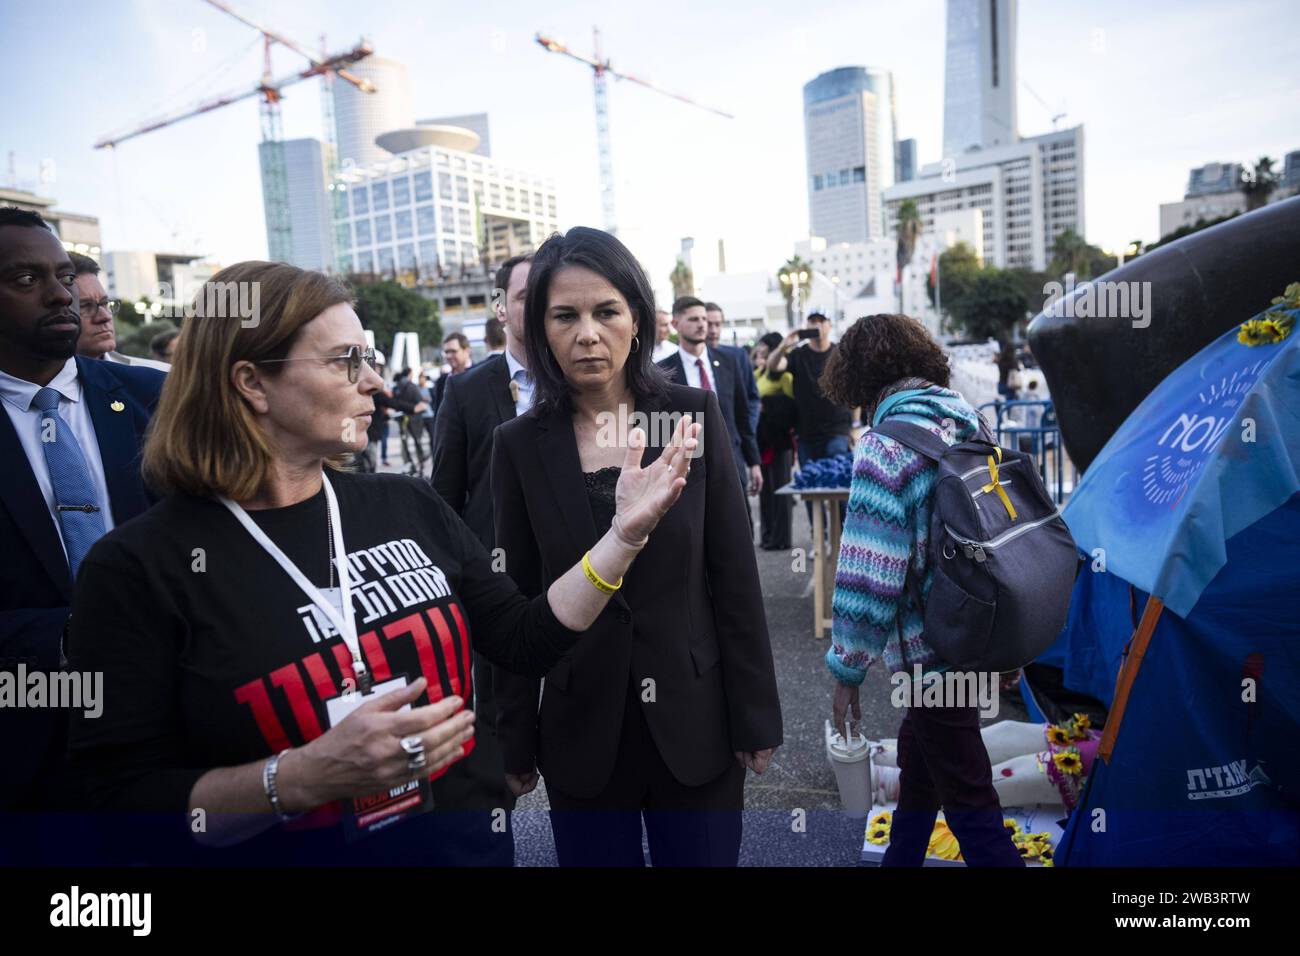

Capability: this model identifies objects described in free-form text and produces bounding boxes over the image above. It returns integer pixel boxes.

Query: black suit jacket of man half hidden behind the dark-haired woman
[430,355,515,550]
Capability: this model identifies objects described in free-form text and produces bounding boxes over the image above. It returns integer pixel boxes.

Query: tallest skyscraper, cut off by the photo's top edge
[944,0,1019,157]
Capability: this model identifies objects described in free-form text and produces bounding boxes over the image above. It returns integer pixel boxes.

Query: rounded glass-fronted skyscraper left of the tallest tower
[803,66,897,243]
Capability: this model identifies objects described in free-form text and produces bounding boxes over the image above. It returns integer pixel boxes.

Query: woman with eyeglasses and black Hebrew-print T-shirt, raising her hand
[68,263,698,865]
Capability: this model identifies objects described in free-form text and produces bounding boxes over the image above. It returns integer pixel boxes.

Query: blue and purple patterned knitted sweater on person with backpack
[826,385,979,685]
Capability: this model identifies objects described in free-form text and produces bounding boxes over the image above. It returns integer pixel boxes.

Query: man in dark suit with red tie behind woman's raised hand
[659,295,763,502]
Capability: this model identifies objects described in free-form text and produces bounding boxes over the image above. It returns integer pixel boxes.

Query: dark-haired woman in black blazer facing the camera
[491,228,781,866]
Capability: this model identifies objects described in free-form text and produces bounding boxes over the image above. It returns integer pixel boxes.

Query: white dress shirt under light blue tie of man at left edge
[0,359,113,554]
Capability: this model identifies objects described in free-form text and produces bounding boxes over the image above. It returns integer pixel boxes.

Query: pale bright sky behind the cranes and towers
[0,0,1300,295]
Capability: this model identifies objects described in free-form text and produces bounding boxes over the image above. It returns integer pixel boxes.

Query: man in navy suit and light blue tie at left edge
[0,208,165,822]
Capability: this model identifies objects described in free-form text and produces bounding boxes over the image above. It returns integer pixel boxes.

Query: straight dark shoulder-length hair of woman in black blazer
[524,226,668,410]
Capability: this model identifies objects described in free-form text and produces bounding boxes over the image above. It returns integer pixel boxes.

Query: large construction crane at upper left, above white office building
[95,0,376,261]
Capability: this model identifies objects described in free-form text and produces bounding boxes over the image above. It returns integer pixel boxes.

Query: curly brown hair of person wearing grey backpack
[820,313,949,408]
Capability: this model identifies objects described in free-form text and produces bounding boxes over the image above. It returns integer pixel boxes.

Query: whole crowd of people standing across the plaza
[0,209,1021,865]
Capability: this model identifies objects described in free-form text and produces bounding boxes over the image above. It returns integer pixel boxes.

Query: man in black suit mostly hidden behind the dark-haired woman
[432,255,537,827]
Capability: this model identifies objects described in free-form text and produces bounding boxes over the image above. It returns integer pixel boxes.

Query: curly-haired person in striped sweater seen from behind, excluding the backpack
[822,315,1024,866]
